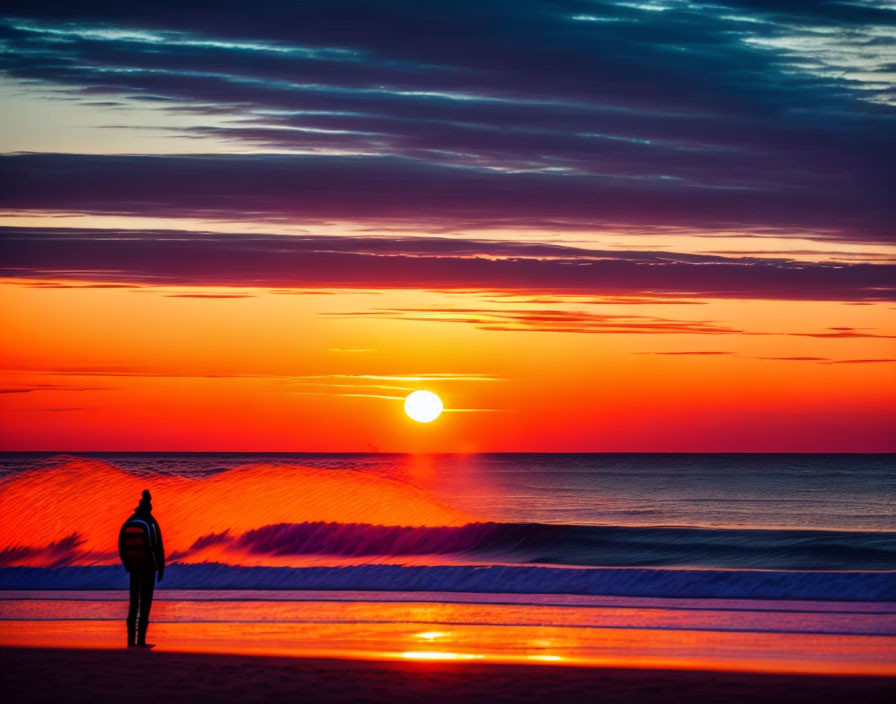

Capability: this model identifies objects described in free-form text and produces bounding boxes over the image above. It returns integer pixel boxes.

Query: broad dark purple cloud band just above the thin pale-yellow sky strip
[0,154,896,241]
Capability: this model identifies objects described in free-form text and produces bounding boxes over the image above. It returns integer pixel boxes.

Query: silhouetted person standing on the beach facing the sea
[118,489,165,648]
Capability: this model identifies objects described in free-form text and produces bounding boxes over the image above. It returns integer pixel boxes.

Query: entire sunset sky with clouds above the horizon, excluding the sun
[0,0,896,452]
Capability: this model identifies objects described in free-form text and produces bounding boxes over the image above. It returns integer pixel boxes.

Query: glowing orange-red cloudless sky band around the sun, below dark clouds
[0,281,896,452]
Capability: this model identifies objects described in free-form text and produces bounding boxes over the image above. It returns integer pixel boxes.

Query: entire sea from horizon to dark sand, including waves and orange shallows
[0,453,896,674]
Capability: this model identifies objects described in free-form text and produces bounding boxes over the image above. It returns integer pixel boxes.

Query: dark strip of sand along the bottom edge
[0,648,896,704]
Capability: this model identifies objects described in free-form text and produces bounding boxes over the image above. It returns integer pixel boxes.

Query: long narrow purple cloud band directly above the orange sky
[0,228,896,302]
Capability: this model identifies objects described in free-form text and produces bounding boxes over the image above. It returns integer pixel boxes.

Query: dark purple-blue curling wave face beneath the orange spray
[7,521,896,571]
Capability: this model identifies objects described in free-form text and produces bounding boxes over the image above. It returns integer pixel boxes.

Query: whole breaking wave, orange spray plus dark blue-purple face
[0,458,896,576]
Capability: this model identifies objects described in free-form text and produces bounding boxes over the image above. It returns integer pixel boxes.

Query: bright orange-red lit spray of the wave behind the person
[0,459,471,567]
